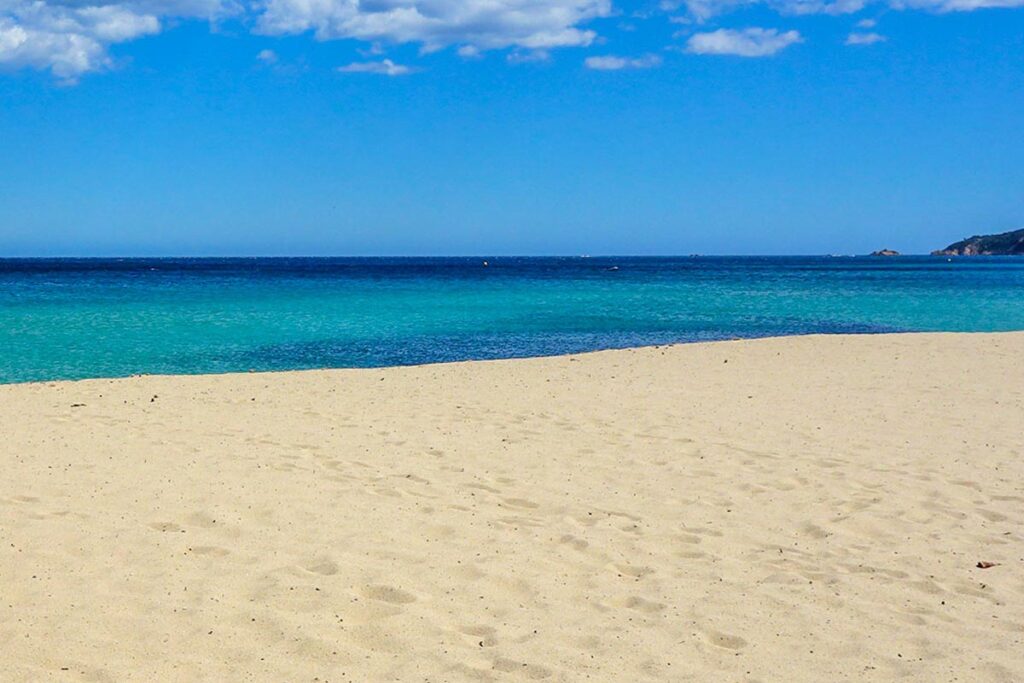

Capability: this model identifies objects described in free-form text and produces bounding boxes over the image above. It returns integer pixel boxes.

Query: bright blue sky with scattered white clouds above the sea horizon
[0,0,1024,256]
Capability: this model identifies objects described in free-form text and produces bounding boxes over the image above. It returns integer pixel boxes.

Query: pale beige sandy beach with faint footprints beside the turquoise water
[0,334,1024,682]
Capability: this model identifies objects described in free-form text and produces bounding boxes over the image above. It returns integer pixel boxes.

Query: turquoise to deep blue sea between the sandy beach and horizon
[0,257,1024,383]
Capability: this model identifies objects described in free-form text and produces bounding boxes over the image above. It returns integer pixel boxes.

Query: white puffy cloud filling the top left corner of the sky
[0,0,233,82]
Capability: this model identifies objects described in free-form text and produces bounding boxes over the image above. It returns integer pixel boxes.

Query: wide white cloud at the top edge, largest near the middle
[258,0,611,51]
